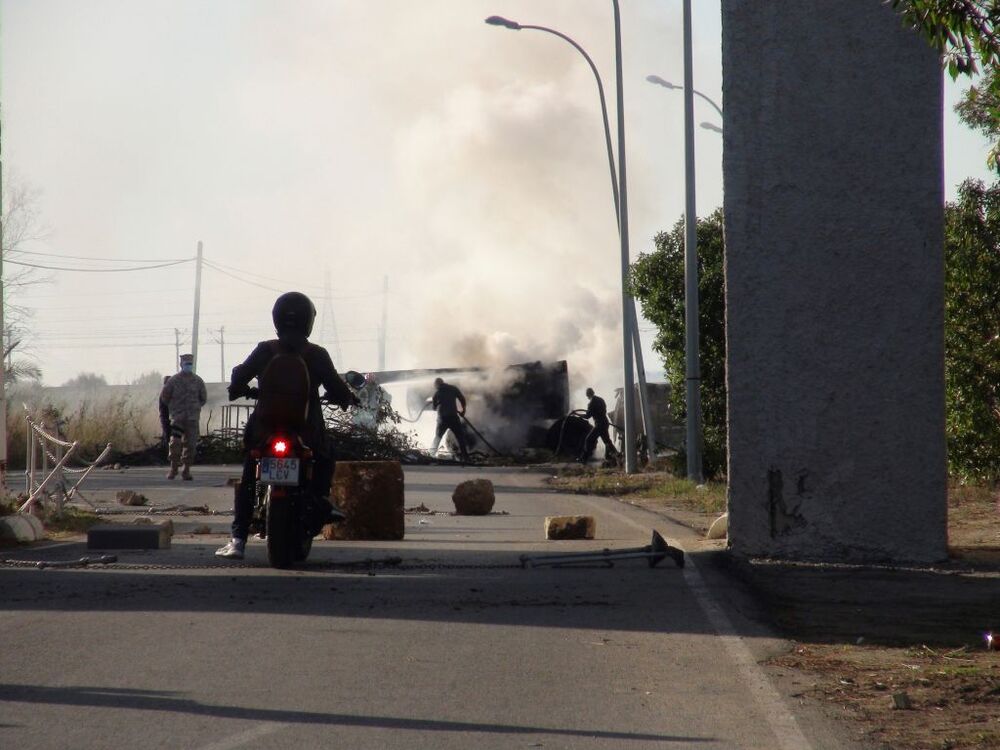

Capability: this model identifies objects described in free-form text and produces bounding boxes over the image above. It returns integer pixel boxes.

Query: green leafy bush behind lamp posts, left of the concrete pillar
[631,209,726,478]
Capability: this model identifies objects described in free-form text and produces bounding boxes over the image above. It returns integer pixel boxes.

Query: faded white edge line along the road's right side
[579,498,812,750]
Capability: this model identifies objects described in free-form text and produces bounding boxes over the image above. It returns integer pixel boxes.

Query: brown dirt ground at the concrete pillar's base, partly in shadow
[733,487,1000,750]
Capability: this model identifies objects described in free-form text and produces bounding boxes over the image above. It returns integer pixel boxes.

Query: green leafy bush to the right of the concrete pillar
[945,180,1000,480]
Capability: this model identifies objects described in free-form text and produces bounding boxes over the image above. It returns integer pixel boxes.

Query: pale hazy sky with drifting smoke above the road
[0,0,986,394]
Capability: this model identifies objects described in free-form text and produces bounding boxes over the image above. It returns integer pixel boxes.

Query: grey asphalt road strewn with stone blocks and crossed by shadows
[0,467,857,750]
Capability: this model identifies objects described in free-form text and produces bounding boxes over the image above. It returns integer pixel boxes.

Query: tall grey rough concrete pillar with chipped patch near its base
[722,0,947,561]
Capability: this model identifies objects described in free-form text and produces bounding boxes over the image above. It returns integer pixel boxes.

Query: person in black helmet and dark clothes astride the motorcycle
[215,292,357,560]
